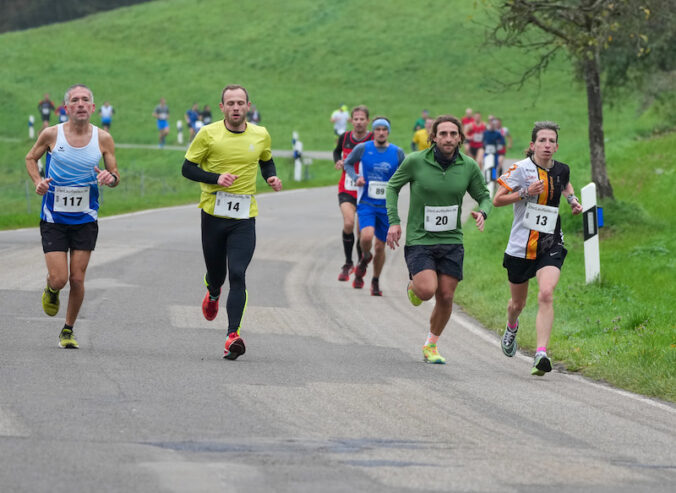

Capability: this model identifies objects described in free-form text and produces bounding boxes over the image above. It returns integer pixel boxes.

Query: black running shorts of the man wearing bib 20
[404,245,465,281]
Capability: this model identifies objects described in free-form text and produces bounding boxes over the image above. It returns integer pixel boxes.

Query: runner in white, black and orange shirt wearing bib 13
[493,122,582,376]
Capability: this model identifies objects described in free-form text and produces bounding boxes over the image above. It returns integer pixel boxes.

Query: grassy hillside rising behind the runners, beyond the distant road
[0,0,664,152]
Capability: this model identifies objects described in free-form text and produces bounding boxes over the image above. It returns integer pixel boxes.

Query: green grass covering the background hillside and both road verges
[0,0,676,401]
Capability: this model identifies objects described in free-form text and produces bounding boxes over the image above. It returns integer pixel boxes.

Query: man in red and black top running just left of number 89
[333,105,373,281]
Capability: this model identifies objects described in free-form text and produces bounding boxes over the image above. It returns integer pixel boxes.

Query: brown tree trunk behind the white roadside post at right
[583,53,614,199]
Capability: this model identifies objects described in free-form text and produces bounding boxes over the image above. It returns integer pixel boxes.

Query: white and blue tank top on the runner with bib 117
[40,123,102,224]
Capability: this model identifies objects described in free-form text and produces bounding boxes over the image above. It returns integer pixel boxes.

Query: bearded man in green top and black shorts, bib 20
[386,115,491,364]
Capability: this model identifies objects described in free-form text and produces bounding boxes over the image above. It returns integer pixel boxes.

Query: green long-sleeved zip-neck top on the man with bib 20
[386,146,492,245]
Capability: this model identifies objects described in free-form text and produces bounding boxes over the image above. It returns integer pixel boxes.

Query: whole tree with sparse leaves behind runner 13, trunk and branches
[489,0,674,198]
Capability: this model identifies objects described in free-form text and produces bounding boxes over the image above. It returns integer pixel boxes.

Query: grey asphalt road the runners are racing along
[0,187,676,493]
